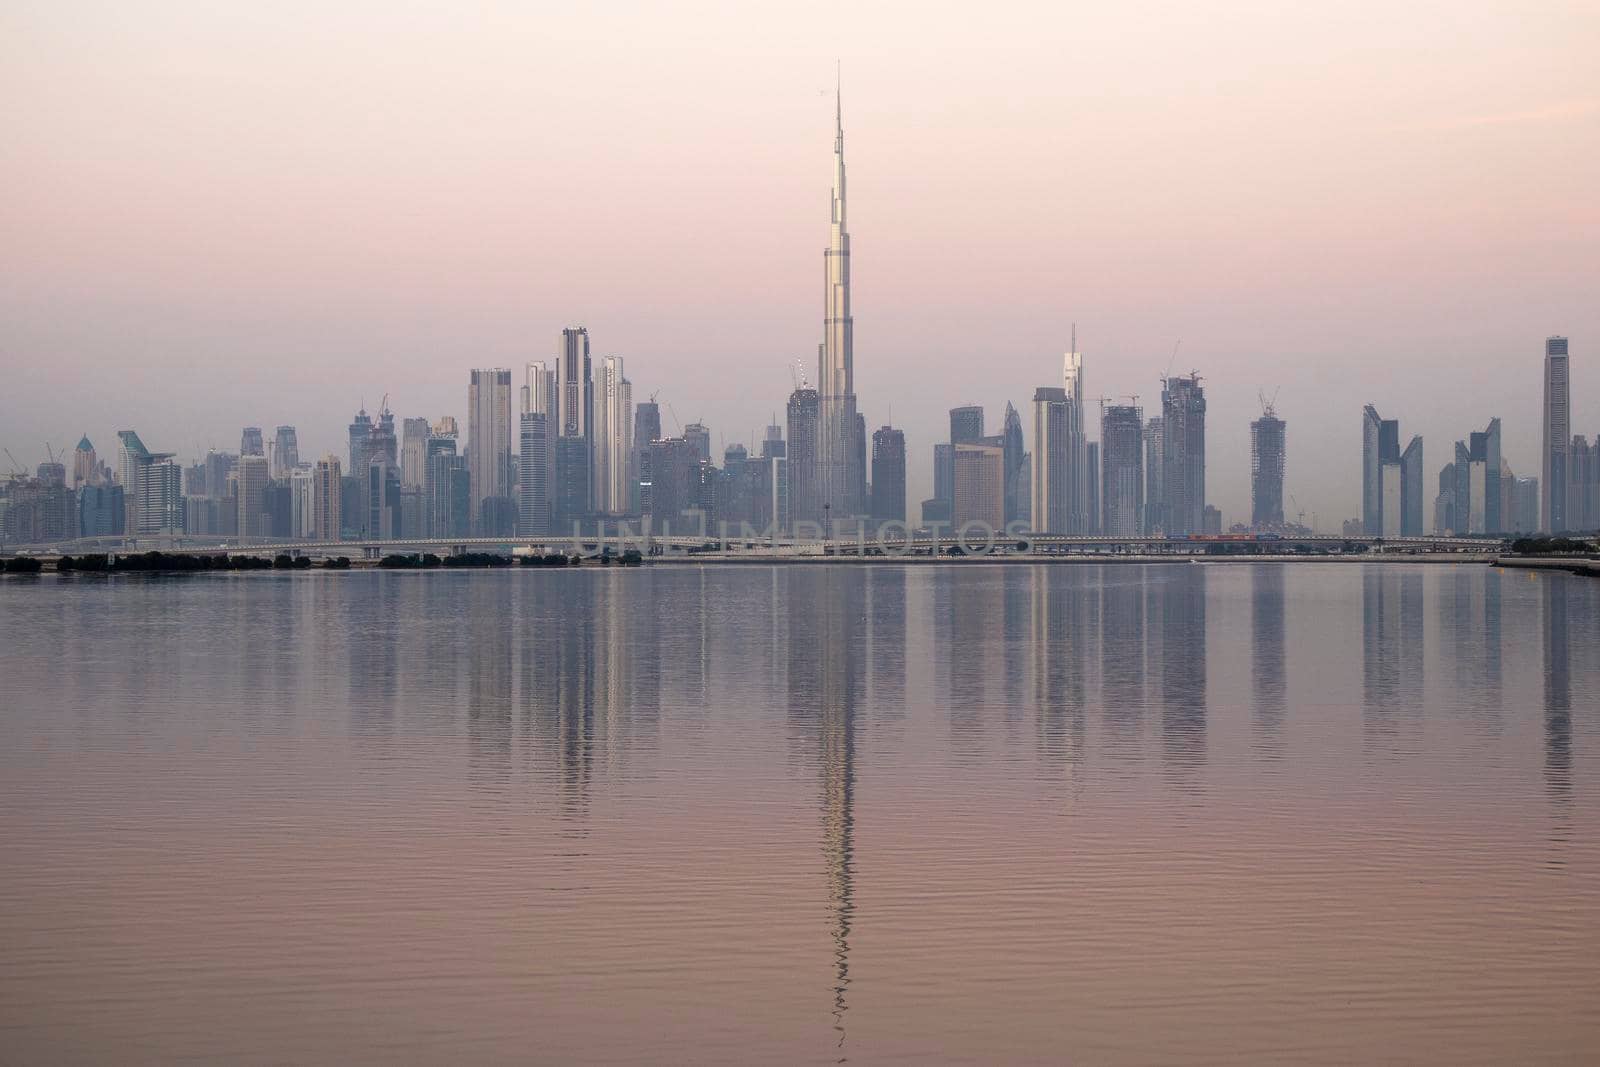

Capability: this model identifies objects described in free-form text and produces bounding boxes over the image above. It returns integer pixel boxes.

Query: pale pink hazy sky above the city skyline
[0,0,1600,530]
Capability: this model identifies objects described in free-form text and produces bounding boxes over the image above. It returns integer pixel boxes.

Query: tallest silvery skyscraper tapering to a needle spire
[819,85,866,518]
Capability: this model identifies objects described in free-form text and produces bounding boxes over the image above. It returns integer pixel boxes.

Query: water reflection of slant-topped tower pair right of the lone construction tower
[1362,563,1426,750]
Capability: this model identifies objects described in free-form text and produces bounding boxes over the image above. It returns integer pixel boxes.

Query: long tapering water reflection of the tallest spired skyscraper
[784,566,870,1046]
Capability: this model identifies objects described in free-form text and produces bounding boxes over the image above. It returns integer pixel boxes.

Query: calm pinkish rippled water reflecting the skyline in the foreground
[0,563,1600,1064]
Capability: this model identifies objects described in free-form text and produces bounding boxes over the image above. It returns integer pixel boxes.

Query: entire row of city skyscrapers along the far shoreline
[0,94,1600,542]
